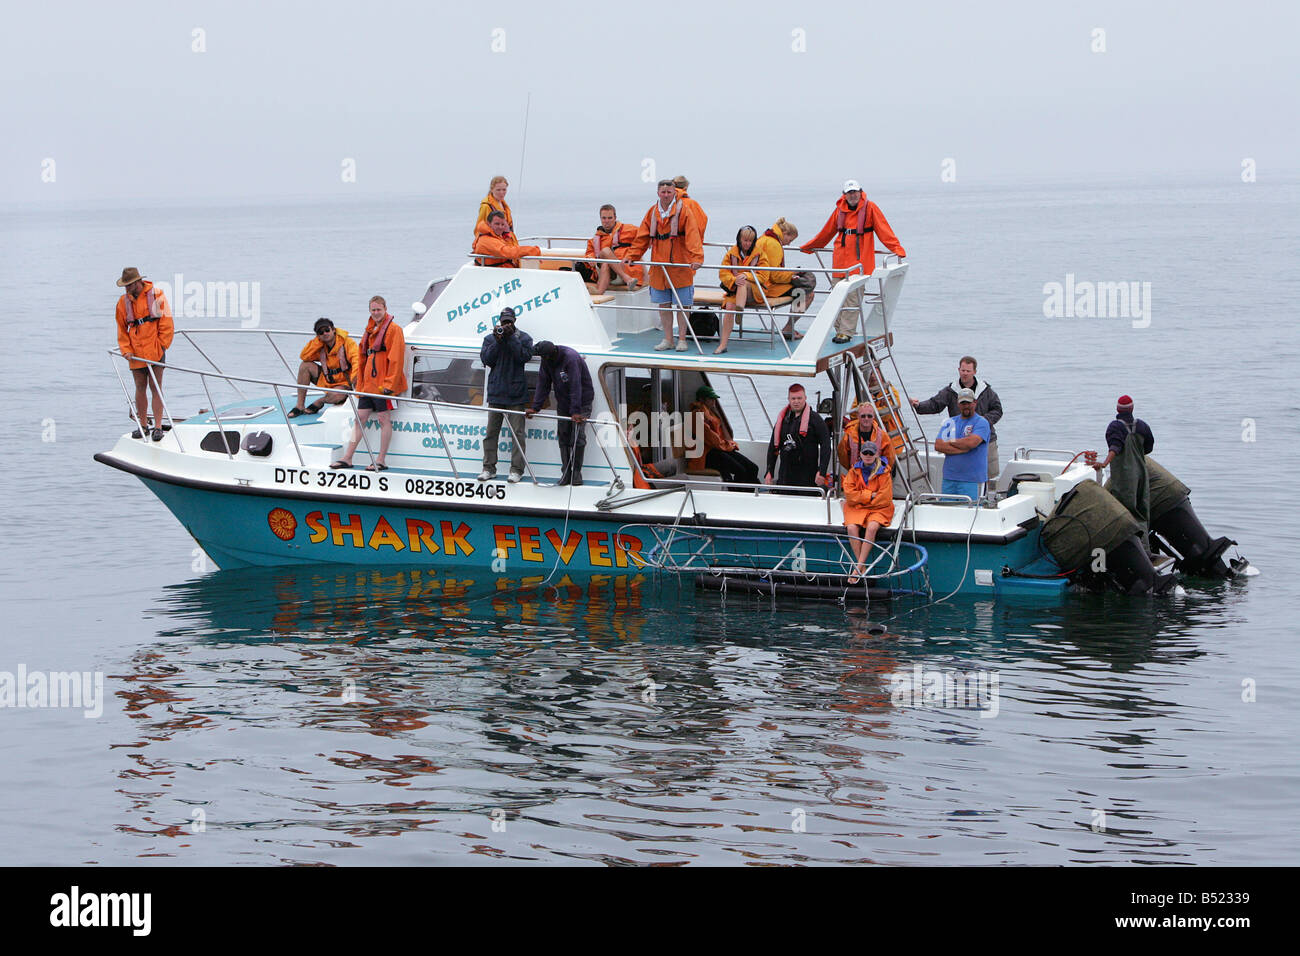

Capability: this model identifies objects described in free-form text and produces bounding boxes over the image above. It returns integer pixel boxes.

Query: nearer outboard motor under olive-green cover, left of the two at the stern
[1041,481,1178,594]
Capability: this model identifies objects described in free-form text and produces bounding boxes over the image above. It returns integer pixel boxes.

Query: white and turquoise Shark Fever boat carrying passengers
[95,237,1245,600]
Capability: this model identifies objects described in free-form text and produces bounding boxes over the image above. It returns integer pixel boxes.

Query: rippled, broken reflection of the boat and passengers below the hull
[106,567,1235,865]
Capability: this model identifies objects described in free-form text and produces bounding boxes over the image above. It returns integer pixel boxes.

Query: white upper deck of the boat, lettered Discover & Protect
[406,237,907,376]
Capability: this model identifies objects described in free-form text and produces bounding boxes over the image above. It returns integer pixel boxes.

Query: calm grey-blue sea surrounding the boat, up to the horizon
[0,183,1300,865]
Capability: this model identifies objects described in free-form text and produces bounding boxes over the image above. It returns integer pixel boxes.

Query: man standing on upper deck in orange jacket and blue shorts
[623,179,705,352]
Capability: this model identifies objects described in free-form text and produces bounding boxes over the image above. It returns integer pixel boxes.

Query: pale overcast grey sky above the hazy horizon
[0,0,1300,202]
